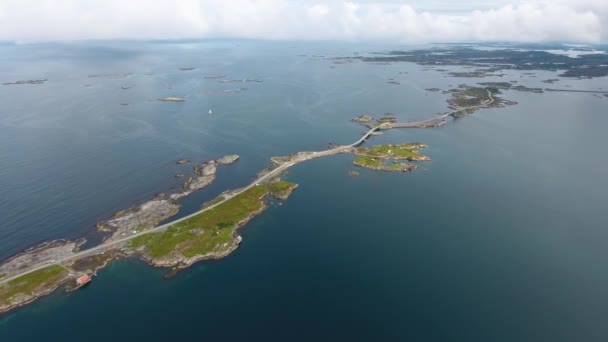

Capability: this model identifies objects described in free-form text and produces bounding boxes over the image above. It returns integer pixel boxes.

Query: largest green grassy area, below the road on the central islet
[130,181,296,258]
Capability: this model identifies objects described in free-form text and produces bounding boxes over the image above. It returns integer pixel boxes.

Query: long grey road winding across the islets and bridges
[0,89,494,285]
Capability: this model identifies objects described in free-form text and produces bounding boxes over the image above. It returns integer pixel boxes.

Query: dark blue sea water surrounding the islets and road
[0,41,608,341]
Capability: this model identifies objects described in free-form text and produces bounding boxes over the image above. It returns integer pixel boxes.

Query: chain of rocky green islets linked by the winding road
[0,80,505,313]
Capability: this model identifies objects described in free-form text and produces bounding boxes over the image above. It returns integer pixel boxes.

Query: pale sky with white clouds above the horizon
[0,0,608,43]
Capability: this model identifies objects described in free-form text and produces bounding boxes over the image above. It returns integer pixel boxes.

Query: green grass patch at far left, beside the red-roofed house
[0,265,68,303]
